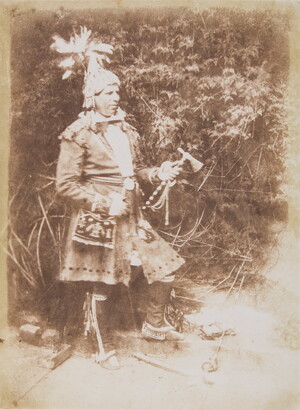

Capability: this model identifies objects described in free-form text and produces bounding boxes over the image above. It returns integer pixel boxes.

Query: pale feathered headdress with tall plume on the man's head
[51,27,120,108]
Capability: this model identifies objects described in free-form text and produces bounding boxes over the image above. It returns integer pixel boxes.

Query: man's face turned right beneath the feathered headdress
[94,84,120,117]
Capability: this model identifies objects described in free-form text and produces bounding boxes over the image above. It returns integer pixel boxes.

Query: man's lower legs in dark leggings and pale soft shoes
[85,282,184,370]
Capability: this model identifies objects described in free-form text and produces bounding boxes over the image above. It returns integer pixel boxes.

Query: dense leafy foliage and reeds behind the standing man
[9,5,289,304]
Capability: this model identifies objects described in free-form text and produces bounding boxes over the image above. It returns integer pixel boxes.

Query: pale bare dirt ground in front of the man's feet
[0,229,300,410]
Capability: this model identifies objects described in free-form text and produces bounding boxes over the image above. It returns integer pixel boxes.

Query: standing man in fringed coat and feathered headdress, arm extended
[52,28,184,369]
